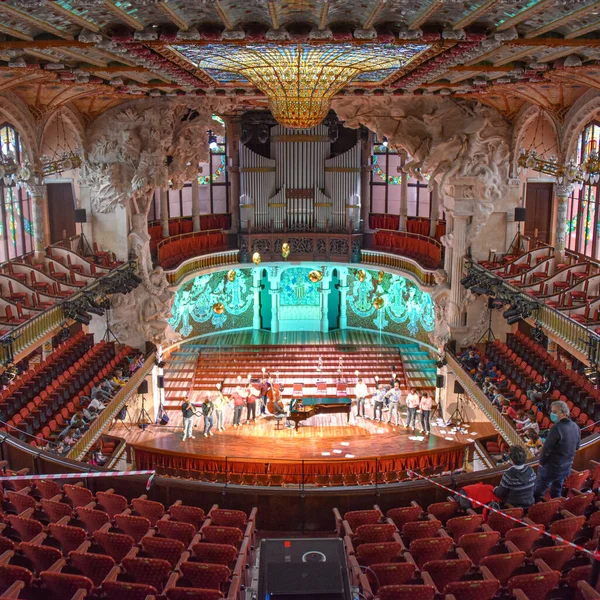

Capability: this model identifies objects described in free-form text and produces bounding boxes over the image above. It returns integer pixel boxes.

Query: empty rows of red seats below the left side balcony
[0,342,120,443]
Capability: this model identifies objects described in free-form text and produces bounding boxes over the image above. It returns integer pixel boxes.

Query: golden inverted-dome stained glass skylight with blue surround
[174,43,429,129]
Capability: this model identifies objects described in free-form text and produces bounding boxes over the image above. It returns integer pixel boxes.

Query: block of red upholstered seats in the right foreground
[334,461,600,600]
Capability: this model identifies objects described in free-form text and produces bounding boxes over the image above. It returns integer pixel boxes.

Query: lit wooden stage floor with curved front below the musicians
[119,408,495,485]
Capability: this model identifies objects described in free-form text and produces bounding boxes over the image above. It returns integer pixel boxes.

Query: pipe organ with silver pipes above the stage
[240,125,360,233]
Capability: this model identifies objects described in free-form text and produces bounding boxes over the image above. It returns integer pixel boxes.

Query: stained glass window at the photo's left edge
[0,123,33,262]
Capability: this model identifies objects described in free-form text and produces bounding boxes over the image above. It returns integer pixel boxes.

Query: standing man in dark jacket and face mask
[534,400,581,502]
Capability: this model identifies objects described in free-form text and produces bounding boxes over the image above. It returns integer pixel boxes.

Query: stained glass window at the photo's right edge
[566,121,600,259]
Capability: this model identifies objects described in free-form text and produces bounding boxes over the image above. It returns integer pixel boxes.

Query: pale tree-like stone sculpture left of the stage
[85,99,223,347]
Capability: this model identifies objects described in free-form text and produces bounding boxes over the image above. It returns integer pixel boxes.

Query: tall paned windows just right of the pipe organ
[370,138,431,224]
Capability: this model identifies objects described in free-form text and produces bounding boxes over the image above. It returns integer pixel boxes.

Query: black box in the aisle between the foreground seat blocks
[258,538,351,600]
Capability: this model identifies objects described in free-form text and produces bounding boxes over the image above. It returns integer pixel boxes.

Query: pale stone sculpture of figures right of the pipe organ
[332,96,510,245]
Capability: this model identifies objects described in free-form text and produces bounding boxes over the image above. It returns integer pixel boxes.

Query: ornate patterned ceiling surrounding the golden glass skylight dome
[0,0,600,123]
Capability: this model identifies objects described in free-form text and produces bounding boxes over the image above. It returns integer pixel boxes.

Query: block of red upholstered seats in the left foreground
[0,480,256,600]
